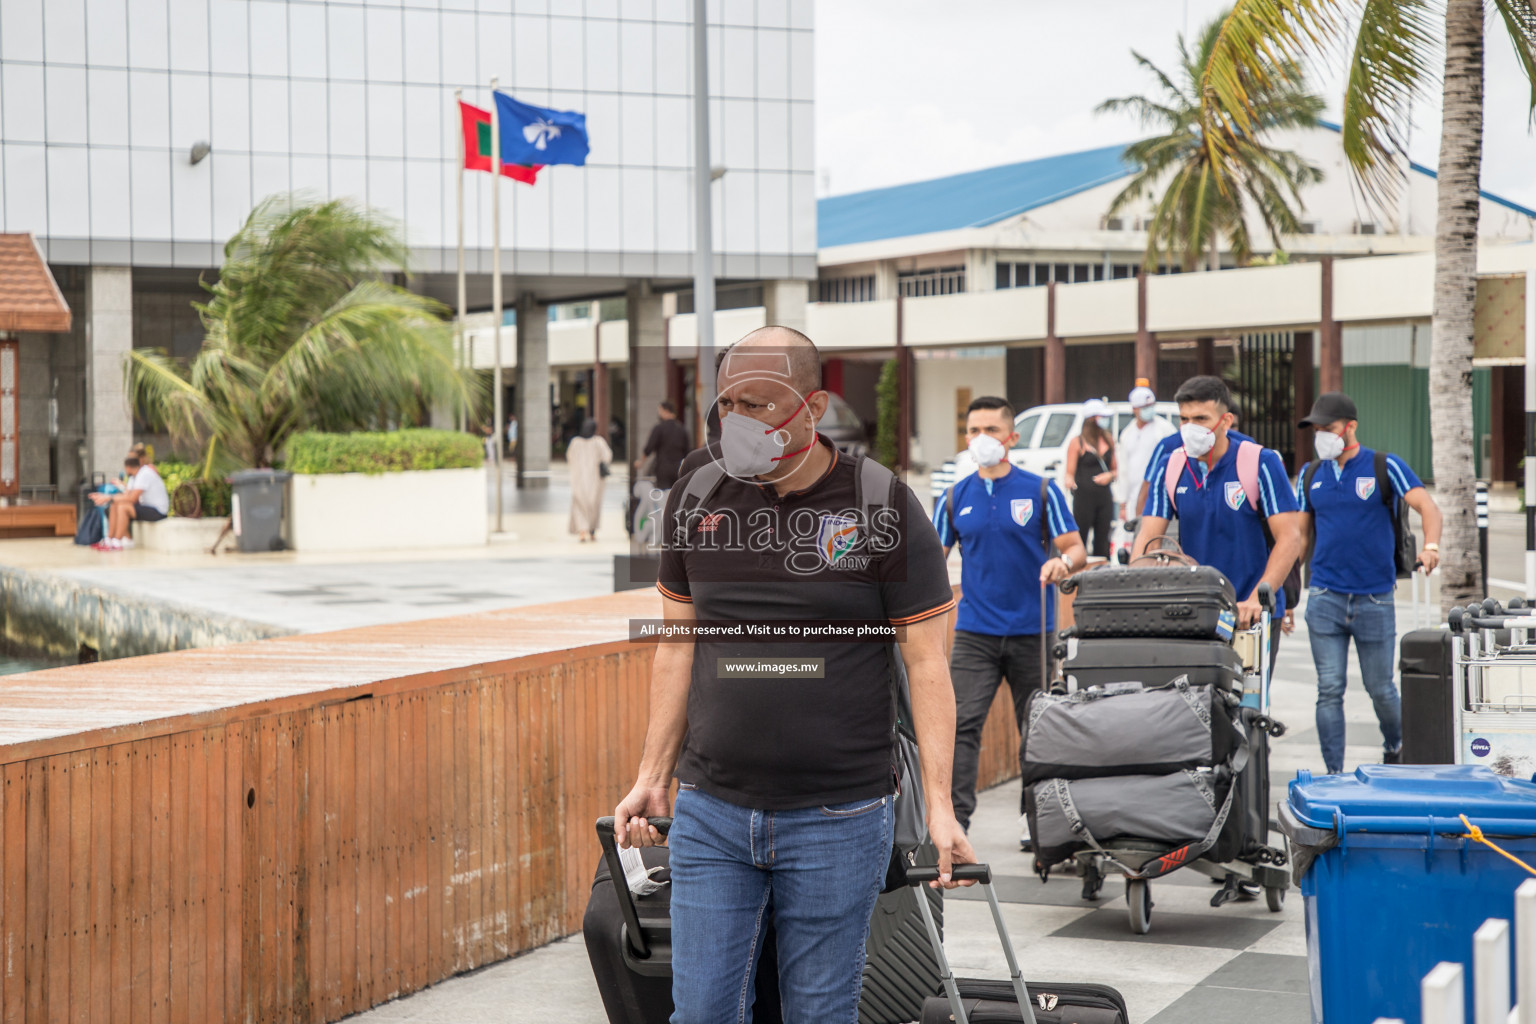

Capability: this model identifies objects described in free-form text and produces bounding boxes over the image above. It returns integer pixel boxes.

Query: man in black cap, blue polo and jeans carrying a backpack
[1296,391,1441,775]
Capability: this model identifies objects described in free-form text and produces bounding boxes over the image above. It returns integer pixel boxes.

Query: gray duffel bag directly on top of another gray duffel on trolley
[1018,676,1243,786]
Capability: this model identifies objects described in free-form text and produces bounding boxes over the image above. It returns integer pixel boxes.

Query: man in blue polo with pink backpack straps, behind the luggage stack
[1132,376,1303,629]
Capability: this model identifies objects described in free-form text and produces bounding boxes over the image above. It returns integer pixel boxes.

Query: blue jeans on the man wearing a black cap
[1307,586,1402,774]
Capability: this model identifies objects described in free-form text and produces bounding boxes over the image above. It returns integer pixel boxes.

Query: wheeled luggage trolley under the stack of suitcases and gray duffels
[1050,577,1290,935]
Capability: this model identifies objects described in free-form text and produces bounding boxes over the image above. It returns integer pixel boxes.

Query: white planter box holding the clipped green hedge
[287,467,488,551]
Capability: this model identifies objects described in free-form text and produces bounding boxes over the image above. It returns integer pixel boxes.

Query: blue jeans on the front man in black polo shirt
[667,783,894,1024]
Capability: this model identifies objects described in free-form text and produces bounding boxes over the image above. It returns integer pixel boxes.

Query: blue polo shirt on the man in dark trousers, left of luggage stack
[934,465,1077,637]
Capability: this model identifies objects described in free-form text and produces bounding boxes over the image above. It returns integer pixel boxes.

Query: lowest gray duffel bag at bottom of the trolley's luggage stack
[1025,768,1232,869]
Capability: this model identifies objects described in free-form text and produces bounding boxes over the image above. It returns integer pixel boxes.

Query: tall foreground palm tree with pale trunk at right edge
[1201,0,1536,611]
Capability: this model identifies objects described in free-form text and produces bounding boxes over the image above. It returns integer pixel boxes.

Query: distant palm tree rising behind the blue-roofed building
[1098,17,1322,270]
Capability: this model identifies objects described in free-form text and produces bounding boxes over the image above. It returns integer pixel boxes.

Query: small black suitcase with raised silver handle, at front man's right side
[906,864,1130,1024]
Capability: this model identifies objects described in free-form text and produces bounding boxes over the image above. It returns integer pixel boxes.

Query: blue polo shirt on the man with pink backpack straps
[1141,433,1296,619]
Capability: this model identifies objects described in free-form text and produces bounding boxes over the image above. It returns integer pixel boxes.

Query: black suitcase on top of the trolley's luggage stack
[1061,565,1238,642]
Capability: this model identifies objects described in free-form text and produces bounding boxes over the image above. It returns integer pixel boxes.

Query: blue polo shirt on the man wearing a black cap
[1296,447,1424,594]
